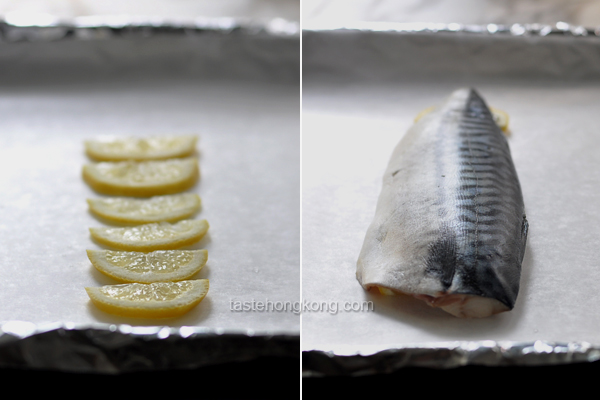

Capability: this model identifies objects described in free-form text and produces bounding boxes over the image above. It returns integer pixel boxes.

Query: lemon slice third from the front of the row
[90,219,208,252]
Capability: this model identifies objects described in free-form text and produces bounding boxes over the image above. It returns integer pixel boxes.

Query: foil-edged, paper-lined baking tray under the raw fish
[302,24,600,377]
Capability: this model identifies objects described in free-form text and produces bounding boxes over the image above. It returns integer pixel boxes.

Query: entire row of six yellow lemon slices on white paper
[83,136,209,318]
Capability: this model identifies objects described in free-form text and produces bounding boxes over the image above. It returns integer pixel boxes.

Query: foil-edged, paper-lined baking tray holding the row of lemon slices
[0,18,300,374]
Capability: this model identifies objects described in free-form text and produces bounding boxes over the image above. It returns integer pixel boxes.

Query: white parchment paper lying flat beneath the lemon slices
[0,61,300,334]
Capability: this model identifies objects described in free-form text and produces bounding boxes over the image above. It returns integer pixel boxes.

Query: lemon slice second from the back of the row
[83,158,199,197]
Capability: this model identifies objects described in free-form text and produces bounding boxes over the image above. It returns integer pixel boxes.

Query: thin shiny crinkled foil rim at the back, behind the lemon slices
[0,16,300,43]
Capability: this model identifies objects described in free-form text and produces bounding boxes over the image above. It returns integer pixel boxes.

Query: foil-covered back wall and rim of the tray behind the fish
[303,24,600,83]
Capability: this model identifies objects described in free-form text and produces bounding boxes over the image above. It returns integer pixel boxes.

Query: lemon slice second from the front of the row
[87,250,208,283]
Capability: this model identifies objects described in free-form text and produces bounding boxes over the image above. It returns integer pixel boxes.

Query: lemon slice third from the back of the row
[87,193,201,224]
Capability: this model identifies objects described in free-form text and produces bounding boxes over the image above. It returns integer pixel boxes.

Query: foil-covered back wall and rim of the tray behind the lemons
[0,17,300,84]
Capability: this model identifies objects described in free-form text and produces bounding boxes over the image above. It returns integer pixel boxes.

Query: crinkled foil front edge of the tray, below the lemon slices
[0,321,300,374]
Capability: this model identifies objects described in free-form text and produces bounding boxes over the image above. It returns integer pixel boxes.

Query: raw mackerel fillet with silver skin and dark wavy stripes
[356,88,528,318]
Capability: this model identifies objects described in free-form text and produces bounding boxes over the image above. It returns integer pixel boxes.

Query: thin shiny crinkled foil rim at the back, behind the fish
[302,22,600,37]
